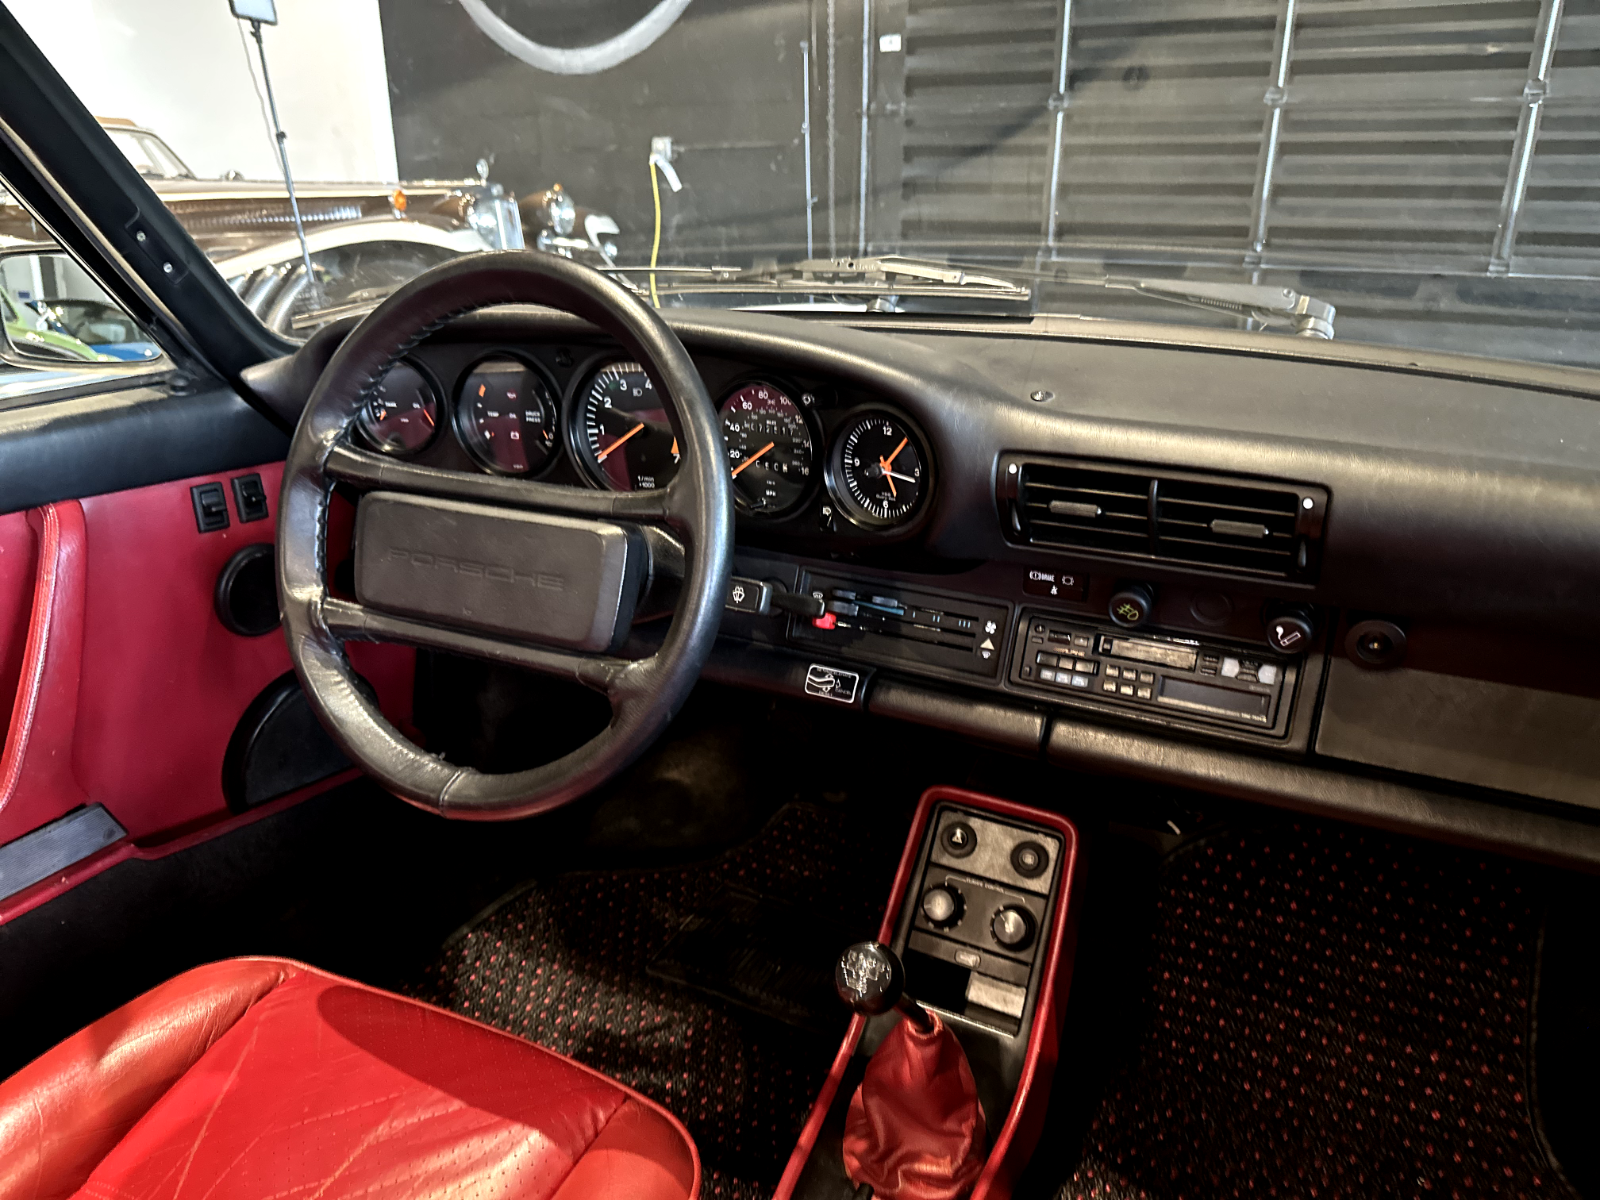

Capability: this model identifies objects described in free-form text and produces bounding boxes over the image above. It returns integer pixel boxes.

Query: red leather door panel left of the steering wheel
[0,464,414,843]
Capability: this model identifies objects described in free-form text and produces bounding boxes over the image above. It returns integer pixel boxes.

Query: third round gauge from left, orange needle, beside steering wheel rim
[574,362,680,491]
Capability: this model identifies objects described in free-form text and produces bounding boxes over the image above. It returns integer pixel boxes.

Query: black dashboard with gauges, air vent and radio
[240,309,1600,854]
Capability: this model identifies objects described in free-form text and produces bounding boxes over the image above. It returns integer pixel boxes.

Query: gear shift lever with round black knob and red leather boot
[834,942,986,1200]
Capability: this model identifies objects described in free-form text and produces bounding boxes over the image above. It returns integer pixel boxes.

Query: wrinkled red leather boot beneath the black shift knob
[845,1014,984,1200]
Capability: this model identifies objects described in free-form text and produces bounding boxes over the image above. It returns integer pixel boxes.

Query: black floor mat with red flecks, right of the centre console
[1058,824,1571,1200]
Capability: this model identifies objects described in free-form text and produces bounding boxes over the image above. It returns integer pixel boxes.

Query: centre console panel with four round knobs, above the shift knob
[906,806,1061,1032]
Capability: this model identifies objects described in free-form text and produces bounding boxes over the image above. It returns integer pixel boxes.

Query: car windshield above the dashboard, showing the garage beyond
[14,0,1600,366]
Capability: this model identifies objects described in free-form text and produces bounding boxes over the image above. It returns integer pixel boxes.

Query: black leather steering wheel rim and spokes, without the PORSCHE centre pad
[277,251,733,821]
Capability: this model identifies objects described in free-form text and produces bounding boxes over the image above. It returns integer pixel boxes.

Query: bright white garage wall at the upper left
[14,0,397,181]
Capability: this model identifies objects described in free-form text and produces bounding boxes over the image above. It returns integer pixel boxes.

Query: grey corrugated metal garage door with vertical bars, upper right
[889,0,1600,278]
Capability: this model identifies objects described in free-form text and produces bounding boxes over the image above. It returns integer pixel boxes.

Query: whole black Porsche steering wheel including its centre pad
[277,251,733,821]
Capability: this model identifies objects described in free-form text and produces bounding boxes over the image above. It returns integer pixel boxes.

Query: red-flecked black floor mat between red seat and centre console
[413,805,899,1200]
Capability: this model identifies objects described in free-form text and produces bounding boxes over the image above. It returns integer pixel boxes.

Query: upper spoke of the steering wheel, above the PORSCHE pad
[323,442,683,525]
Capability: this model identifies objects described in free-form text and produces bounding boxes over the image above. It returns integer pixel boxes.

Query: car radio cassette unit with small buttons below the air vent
[1011,613,1296,730]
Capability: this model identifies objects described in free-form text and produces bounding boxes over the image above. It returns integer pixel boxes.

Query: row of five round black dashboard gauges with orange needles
[355,352,931,531]
